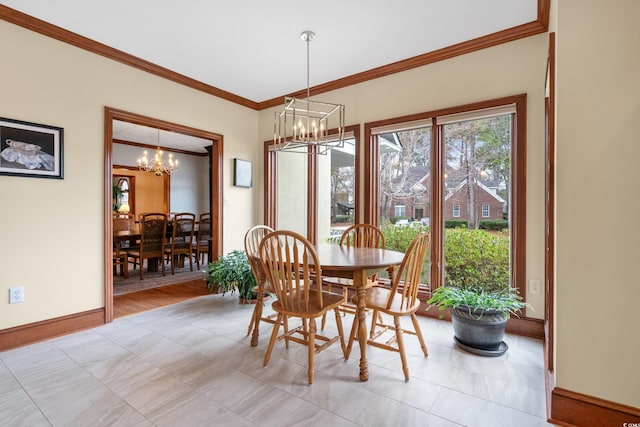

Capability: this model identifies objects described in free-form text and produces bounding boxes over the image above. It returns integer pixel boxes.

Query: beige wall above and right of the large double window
[260,34,547,318]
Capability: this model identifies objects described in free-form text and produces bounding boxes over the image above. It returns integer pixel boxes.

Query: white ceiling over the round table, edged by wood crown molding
[0,0,539,102]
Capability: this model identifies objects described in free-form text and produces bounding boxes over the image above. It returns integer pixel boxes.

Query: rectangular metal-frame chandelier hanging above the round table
[273,31,344,154]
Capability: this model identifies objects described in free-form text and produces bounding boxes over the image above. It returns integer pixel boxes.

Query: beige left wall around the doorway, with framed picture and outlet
[0,21,262,329]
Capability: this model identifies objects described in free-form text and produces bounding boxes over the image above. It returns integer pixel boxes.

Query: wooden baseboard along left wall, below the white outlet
[0,308,105,351]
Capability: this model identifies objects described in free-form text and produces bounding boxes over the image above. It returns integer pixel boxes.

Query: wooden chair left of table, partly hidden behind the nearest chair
[244,225,277,346]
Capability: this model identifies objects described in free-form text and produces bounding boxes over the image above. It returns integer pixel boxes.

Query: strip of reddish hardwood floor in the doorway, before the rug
[113,279,209,318]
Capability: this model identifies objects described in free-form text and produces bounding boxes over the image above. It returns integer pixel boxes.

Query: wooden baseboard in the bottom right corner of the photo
[549,387,640,427]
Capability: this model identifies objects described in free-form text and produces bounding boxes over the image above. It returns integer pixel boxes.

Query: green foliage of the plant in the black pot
[427,286,529,318]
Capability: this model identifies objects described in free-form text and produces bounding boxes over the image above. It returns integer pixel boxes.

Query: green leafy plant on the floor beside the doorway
[204,249,256,300]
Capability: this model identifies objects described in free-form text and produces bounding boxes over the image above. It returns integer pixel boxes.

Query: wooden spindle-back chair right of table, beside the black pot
[346,232,429,381]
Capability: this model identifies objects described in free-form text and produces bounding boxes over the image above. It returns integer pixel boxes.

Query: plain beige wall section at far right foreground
[555,0,640,407]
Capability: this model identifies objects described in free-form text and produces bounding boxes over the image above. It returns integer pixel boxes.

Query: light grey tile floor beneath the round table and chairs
[0,294,550,427]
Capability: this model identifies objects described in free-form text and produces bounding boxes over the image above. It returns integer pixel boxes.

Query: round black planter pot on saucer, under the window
[451,306,509,357]
